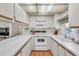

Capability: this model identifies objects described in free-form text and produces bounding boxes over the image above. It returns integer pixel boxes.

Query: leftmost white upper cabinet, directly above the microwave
[0,3,14,19]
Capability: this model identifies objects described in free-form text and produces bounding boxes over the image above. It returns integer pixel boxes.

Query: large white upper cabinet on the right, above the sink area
[69,3,79,27]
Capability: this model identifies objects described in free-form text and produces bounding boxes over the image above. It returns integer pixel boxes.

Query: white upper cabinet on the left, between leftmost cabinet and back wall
[15,4,29,24]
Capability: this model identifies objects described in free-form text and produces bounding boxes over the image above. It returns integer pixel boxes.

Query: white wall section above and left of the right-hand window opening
[54,10,68,28]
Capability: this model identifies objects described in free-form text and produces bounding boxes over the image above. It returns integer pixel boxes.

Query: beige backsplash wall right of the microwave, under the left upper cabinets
[12,23,28,36]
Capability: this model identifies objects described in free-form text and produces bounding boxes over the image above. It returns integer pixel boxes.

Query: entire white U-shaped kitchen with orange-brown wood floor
[0,3,79,56]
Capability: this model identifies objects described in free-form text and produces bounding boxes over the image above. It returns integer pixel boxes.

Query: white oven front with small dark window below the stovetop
[35,37,47,50]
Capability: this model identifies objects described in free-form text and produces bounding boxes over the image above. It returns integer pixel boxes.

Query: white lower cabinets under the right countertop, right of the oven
[48,39,73,56]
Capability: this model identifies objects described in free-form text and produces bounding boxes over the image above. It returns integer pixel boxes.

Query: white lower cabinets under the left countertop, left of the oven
[16,38,34,56]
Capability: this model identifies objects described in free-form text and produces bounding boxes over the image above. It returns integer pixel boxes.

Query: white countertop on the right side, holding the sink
[51,35,79,56]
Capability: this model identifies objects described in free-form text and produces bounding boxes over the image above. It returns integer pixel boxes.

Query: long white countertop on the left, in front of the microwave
[0,35,31,56]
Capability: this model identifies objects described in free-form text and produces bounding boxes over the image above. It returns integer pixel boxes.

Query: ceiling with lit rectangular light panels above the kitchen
[20,3,68,16]
